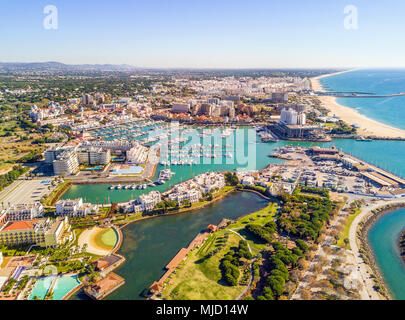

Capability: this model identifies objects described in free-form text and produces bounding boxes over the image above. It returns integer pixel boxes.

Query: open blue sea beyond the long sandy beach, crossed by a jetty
[320,69,405,129]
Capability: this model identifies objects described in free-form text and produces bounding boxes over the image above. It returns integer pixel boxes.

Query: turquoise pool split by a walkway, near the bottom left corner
[29,274,81,300]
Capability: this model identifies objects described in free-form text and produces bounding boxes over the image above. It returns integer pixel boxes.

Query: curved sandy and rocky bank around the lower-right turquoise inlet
[349,201,405,300]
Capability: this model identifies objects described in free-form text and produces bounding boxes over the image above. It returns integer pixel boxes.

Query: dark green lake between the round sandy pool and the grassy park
[74,193,268,300]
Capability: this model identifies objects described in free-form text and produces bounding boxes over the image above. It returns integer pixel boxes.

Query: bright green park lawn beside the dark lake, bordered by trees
[162,203,277,300]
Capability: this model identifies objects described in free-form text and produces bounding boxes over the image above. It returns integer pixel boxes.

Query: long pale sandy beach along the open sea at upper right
[311,71,405,139]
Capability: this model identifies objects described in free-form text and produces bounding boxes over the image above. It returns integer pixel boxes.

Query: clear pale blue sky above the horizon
[0,0,405,68]
